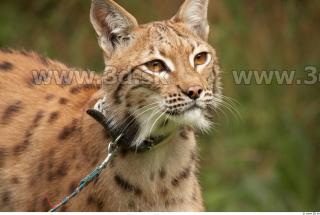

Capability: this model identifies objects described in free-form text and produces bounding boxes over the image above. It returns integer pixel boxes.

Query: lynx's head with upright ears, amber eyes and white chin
[91,0,221,144]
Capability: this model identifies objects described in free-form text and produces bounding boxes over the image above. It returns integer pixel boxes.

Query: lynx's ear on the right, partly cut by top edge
[172,0,209,40]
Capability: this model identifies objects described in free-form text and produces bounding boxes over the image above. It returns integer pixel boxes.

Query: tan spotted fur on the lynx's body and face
[0,1,221,211]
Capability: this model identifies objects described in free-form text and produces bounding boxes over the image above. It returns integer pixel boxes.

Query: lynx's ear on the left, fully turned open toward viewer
[90,0,138,57]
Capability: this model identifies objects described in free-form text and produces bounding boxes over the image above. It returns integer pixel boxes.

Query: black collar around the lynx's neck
[87,109,170,153]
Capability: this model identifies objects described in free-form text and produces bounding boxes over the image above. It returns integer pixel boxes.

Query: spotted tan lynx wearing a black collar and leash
[0,0,222,211]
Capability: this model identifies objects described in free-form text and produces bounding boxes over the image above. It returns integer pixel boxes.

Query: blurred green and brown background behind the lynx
[0,0,320,211]
